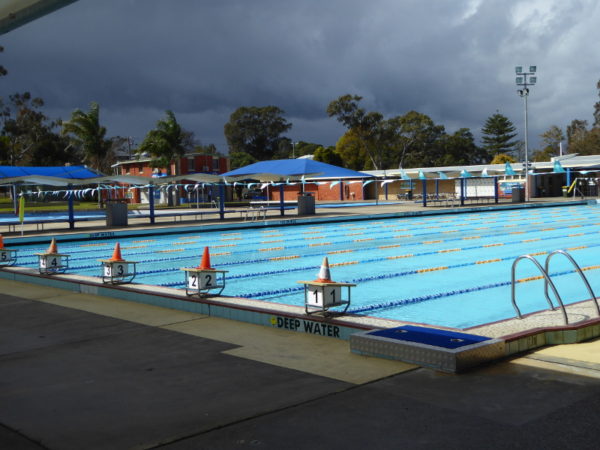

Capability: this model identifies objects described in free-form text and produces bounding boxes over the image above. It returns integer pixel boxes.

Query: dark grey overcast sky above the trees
[0,0,600,156]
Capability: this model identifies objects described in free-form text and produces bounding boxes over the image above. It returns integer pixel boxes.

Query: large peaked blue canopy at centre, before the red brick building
[223,159,372,178]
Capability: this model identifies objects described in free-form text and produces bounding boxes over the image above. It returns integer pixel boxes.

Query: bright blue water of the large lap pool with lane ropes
[8,205,600,328]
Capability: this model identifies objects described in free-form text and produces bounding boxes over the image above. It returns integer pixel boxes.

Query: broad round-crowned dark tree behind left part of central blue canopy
[224,106,292,167]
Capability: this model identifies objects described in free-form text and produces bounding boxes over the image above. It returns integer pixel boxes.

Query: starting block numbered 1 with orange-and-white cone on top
[298,257,356,314]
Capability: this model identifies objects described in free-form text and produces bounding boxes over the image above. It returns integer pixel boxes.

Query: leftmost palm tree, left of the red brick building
[62,102,113,173]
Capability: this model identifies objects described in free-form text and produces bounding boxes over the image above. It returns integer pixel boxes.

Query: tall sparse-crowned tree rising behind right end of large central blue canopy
[327,94,389,170]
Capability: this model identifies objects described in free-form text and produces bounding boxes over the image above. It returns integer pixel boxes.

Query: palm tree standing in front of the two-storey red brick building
[137,110,193,175]
